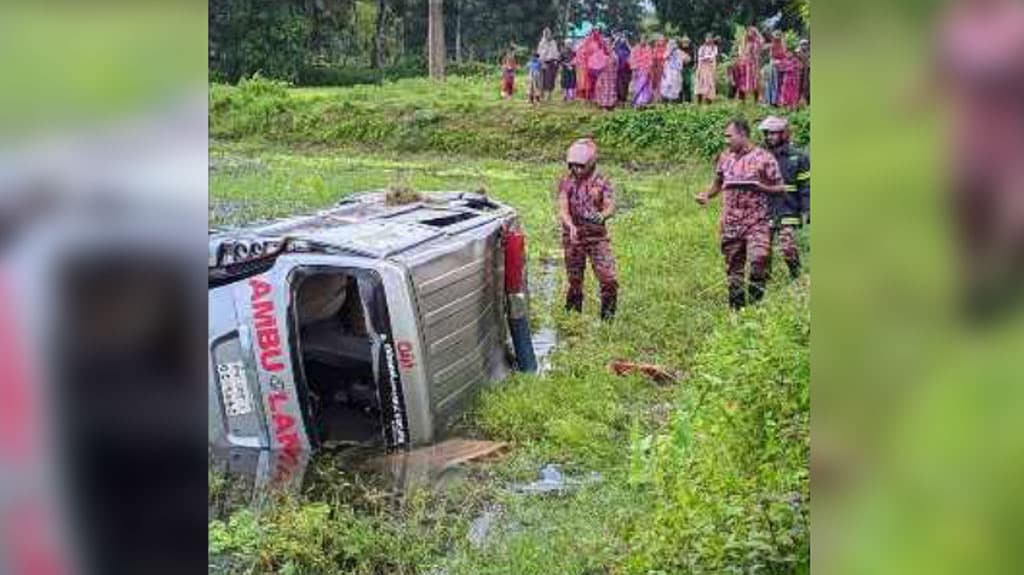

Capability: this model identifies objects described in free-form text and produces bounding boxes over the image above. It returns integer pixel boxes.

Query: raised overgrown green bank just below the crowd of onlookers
[210,76,810,162]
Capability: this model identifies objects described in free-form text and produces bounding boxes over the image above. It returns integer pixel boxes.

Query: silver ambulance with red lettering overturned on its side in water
[208,192,537,452]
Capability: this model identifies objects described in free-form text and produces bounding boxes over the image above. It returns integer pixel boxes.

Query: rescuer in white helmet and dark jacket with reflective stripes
[760,116,811,279]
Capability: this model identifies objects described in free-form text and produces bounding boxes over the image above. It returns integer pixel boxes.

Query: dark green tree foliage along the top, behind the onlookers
[209,0,807,86]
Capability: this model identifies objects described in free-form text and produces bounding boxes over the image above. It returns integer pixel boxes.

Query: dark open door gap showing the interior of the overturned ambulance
[295,270,383,447]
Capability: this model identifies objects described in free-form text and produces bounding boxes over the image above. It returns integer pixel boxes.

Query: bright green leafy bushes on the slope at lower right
[627,285,810,573]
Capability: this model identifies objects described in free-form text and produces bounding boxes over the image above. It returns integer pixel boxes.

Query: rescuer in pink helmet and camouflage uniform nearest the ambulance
[558,138,618,320]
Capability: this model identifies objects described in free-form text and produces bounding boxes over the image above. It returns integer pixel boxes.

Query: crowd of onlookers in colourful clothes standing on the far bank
[501,26,811,109]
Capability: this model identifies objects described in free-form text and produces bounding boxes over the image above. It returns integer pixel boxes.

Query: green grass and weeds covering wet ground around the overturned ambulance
[210,73,810,575]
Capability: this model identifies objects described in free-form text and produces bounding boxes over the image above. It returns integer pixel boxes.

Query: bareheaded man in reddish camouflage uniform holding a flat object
[695,120,784,309]
